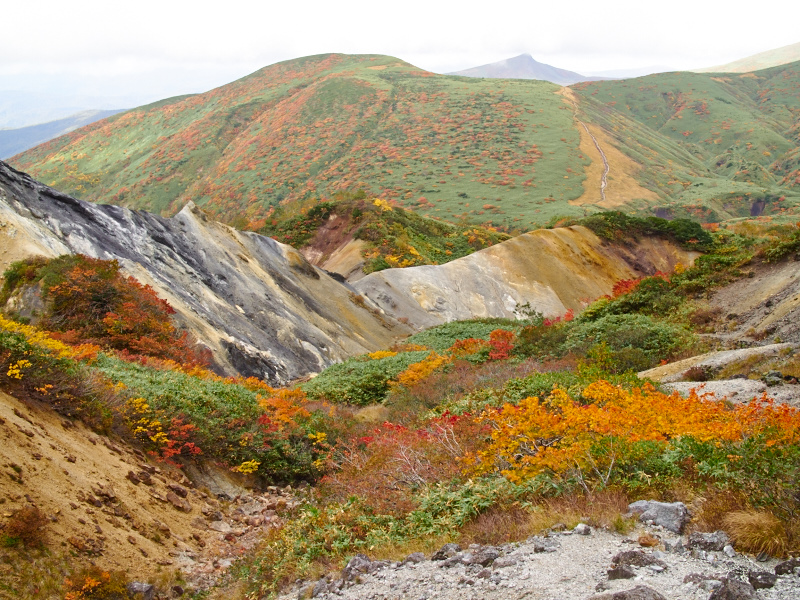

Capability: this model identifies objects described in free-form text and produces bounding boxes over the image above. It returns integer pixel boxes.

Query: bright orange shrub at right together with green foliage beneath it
[470,381,800,504]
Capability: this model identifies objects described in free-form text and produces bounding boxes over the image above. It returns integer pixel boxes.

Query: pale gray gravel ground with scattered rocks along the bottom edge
[281,527,800,600]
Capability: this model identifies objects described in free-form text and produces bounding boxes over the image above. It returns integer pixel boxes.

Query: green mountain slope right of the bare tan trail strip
[574,63,800,221]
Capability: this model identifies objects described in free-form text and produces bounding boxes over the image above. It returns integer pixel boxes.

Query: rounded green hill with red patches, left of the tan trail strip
[12,55,588,226]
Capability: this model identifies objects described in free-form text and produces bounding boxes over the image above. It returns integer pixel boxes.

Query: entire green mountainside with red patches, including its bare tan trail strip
[12,54,800,229]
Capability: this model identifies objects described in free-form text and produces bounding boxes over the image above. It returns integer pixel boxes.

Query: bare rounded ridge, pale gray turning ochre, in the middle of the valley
[354,227,697,328]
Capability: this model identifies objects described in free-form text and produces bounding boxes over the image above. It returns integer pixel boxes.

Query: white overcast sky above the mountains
[0,0,800,103]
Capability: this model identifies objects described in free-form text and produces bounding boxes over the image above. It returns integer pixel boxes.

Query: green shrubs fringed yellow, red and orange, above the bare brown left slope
[95,355,323,482]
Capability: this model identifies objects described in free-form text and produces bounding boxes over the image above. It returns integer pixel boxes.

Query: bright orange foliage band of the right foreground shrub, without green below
[469,380,800,484]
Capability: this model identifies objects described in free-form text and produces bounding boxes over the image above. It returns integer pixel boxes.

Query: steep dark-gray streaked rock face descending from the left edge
[0,162,410,385]
